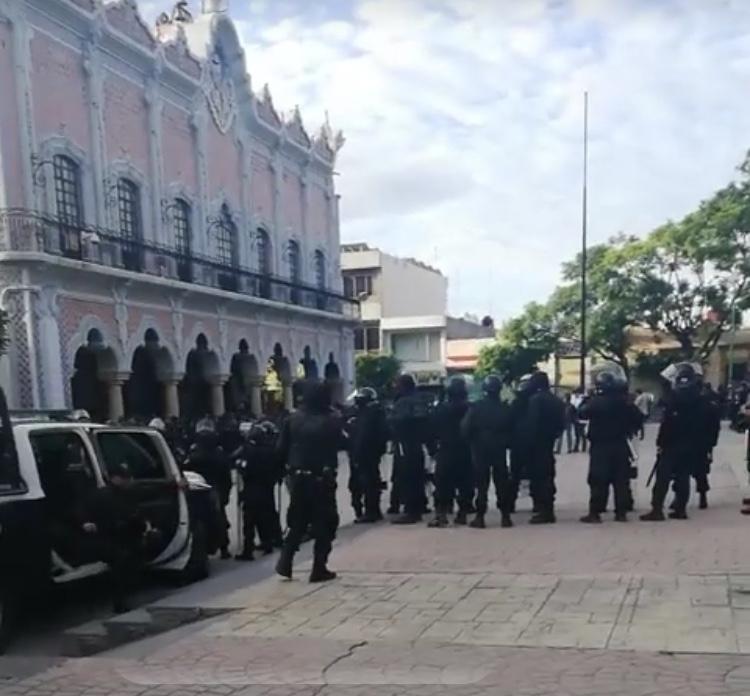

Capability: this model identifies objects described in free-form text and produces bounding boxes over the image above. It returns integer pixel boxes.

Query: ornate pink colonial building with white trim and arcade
[0,0,357,418]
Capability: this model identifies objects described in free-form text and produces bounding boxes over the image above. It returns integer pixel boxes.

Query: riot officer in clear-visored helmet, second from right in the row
[581,364,643,523]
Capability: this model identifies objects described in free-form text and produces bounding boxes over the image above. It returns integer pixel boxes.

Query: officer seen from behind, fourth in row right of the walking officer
[462,375,513,529]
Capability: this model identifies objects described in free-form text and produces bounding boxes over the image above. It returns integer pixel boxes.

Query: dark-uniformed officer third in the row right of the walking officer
[429,377,474,527]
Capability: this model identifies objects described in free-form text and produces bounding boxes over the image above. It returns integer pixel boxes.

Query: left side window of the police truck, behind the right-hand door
[29,431,97,499]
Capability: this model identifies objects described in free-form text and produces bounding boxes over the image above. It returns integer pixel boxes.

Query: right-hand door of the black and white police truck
[91,428,189,565]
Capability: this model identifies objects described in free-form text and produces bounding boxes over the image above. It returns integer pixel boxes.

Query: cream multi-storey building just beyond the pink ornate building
[341,244,448,384]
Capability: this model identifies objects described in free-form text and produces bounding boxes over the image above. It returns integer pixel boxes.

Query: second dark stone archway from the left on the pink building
[123,328,178,421]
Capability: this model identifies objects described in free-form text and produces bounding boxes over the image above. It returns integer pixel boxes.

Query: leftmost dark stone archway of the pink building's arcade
[70,329,123,421]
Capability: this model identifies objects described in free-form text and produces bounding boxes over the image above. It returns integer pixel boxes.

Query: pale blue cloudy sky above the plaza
[141,0,750,320]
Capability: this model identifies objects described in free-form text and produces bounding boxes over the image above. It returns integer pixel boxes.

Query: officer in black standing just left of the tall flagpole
[520,371,564,524]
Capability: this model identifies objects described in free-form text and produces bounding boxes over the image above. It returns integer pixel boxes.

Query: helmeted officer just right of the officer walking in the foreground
[347,387,388,524]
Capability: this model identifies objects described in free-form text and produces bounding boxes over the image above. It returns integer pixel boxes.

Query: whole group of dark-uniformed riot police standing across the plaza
[141,363,719,582]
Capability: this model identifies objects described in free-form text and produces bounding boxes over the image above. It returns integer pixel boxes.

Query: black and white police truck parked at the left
[0,390,218,652]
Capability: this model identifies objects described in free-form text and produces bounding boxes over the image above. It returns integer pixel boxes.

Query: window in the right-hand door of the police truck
[96,432,168,481]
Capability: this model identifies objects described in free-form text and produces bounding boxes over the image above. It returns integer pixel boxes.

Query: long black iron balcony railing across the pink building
[0,209,359,319]
